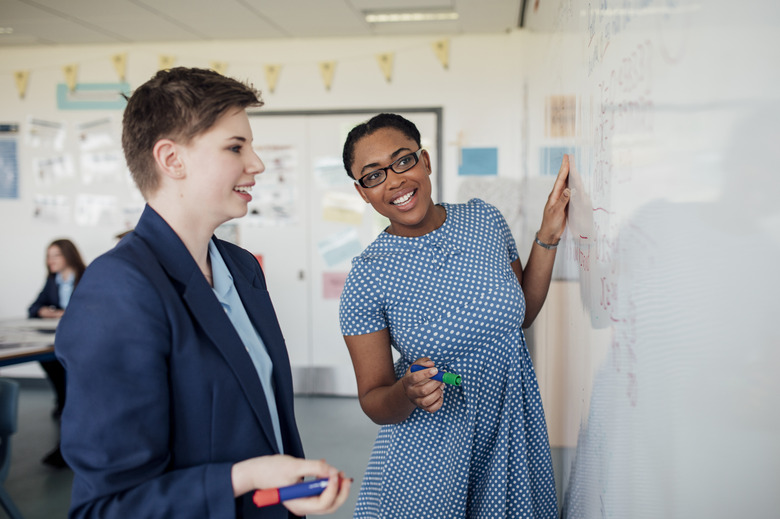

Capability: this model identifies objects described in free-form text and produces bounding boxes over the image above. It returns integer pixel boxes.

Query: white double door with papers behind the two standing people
[245,111,439,396]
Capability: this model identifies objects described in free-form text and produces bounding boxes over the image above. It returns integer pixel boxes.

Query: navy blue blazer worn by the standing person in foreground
[55,206,303,519]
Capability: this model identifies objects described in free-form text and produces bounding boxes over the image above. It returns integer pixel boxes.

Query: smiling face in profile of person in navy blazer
[177,109,265,228]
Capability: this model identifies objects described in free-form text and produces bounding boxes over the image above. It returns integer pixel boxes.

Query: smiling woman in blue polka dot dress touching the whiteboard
[340,114,570,519]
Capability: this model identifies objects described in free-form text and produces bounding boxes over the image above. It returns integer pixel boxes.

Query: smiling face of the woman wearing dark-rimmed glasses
[351,128,443,236]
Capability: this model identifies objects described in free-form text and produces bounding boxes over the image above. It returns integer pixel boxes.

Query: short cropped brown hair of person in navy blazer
[122,67,263,198]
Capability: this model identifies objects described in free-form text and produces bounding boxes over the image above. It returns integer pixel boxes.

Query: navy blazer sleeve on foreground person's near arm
[55,255,236,519]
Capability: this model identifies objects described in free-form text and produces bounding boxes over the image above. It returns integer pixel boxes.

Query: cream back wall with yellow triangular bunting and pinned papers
[0,31,531,378]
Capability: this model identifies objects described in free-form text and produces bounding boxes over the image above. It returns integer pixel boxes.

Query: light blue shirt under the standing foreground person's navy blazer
[209,241,284,453]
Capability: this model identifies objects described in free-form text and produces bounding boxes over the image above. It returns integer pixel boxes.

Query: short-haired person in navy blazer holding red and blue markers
[55,67,350,519]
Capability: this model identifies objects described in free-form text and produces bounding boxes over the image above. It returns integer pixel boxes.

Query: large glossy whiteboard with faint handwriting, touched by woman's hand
[518,0,780,518]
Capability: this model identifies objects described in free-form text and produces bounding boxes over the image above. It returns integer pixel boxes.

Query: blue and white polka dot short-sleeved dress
[340,199,558,519]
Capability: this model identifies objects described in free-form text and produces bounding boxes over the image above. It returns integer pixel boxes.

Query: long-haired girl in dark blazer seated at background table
[27,239,87,419]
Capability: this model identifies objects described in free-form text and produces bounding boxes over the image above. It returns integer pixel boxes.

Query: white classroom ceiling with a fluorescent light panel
[0,0,526,47]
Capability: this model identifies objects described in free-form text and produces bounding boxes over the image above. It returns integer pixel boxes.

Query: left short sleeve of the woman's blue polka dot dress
[339,258,387,335]
